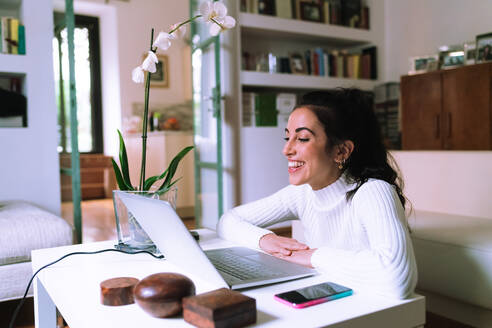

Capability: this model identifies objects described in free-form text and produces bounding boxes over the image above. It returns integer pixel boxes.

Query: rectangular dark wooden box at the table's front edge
[183,288,256,328]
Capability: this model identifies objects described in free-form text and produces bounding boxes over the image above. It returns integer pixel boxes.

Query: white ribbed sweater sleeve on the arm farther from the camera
[217,185,305,248]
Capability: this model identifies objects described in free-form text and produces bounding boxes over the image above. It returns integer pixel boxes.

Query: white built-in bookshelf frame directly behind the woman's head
[221,0,385,210]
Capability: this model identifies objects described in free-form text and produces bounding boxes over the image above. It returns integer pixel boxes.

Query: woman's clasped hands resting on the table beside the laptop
[259,233,316,268]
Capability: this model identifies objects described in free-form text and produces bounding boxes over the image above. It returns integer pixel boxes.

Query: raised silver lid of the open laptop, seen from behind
[120,192,229,288]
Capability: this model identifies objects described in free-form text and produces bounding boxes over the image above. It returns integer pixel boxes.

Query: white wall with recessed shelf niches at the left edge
[0,0,60,214]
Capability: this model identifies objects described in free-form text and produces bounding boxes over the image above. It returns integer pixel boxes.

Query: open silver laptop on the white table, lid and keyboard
[121,193,317,289]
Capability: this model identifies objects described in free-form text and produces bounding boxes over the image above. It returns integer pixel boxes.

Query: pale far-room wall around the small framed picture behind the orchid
[67,0,191,156]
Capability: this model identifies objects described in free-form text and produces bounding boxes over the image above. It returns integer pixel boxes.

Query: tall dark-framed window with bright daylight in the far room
[53,13,103,153]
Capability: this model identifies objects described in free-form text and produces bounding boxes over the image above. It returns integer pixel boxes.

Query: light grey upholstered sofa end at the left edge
[0,201,73,302]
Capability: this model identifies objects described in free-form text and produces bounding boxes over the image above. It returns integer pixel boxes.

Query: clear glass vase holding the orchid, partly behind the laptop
[113,187,178,255]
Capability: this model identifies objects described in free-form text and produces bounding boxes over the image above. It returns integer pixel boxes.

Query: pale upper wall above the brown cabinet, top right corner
[385,0,492,81]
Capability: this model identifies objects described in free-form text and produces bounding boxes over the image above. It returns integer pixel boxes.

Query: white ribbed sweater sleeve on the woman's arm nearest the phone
[311,180,417,298]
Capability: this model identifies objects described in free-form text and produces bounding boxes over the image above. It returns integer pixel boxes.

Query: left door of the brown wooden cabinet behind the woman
[401,72,442,150]
